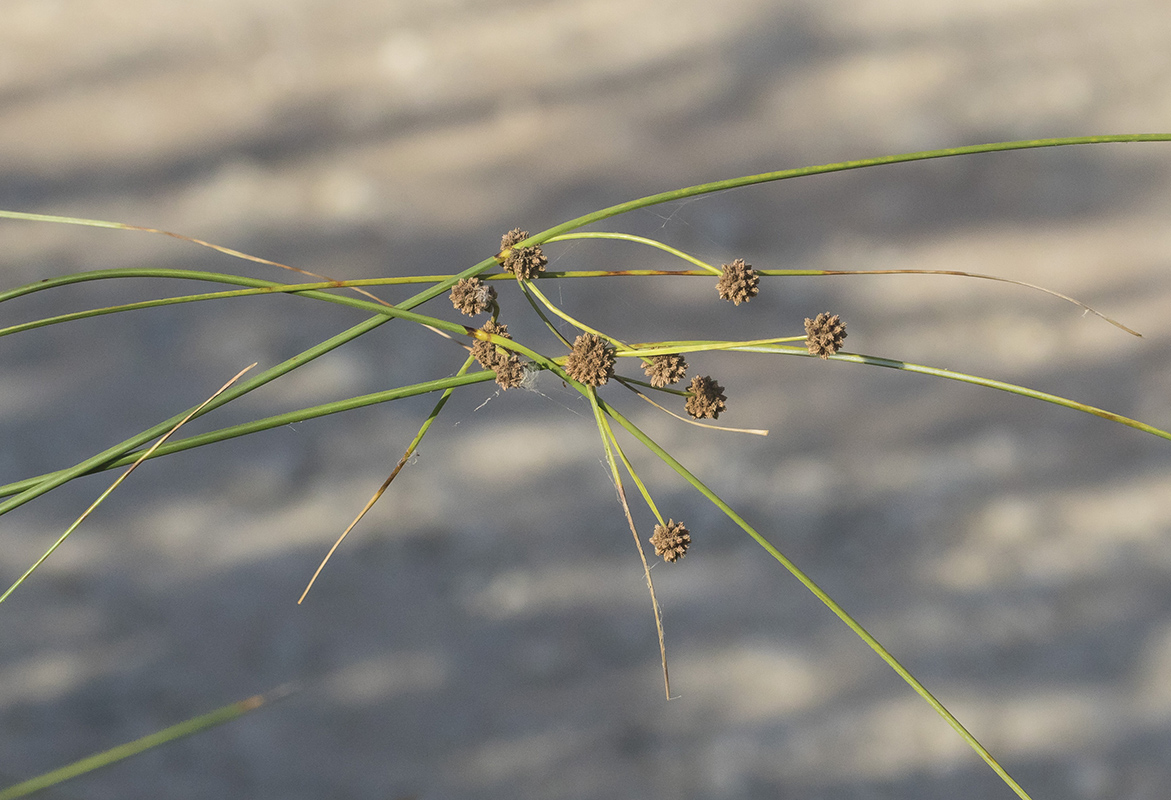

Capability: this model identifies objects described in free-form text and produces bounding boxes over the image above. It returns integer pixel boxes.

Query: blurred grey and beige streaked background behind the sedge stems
[0,0,1171,800]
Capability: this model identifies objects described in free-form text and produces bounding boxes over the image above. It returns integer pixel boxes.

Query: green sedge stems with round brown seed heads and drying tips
[0,134,1171,799]
